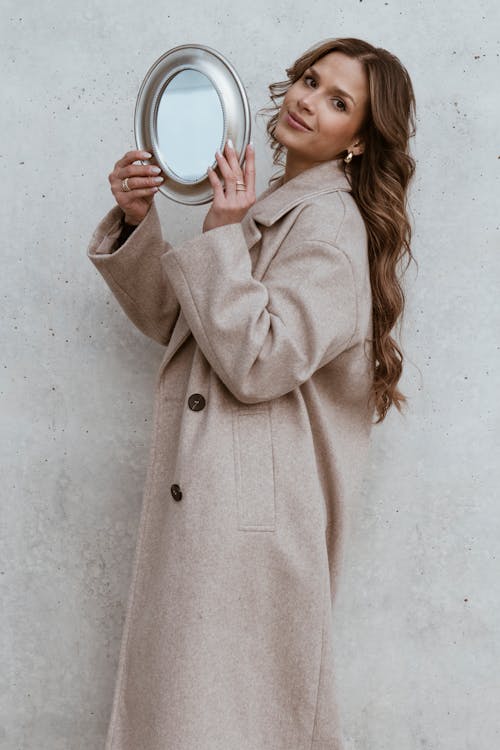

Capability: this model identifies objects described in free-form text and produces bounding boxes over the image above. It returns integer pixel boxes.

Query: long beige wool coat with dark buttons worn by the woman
[87,160,373,750]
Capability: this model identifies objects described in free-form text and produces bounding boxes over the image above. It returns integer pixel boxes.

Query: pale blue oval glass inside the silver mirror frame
[157,68,224,180]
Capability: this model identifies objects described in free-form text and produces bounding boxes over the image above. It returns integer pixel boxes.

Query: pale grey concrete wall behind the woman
[0,0,500,750]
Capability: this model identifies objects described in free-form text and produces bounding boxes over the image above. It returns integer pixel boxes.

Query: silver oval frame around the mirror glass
[134,44,251,206]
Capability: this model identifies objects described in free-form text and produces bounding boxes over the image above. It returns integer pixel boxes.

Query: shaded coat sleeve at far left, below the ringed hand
[87,203,180,346]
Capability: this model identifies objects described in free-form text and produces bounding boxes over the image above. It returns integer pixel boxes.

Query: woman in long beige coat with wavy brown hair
[88,39,415,750]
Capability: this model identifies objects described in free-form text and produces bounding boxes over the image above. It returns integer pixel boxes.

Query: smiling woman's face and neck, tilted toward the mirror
[274,51,369,177]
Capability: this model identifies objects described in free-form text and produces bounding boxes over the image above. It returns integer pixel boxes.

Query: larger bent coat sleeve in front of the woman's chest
[162,204,357,403]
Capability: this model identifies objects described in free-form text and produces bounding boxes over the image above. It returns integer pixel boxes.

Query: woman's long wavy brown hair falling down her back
[258,37,416,424]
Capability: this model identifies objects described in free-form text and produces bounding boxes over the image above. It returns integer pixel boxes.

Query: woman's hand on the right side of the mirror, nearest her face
[203,141,255,232]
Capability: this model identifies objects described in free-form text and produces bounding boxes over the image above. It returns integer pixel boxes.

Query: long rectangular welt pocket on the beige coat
[233,406,276,531]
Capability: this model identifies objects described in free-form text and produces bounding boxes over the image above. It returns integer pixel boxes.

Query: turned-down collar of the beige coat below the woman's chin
[247,159,351,226]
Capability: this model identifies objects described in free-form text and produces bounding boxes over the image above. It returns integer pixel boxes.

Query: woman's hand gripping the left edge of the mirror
[108,151,163,225]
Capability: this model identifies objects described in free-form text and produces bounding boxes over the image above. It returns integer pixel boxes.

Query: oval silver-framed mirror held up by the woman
[134,44,251,205]
